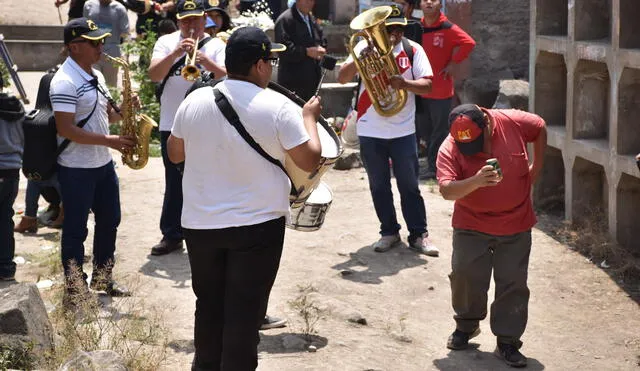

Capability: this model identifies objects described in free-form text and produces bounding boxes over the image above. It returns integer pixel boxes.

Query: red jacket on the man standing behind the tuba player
[421,13,476,99]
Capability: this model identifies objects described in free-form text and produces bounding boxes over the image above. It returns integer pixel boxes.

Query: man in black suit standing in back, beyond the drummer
[275,0,327,100]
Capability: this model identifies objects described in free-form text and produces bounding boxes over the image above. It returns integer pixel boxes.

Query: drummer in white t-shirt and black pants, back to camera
[168,27,321,370]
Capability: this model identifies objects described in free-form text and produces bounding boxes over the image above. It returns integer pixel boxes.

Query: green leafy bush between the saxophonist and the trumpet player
[123,20,160,142]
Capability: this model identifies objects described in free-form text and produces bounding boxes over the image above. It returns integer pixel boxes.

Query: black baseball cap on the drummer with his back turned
[224,26,287,66]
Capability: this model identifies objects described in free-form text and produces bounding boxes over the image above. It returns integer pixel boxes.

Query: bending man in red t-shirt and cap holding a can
[437,104,547,367]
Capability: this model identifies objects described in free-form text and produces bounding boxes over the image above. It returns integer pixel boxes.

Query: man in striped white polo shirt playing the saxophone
[49,18,134,308]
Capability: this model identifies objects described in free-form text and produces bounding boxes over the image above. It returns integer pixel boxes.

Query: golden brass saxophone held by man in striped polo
[104,54,158,170]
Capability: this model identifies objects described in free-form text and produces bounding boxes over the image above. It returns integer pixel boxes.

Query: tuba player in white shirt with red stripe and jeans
[338,5,438,256]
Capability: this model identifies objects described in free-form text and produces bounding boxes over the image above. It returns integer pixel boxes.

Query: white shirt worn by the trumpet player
[151,30,227,131]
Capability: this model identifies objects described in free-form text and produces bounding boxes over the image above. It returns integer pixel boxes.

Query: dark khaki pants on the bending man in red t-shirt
[449,229,531,347]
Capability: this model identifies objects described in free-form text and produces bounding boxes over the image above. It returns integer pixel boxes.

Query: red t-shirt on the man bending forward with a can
[436,110,544,236]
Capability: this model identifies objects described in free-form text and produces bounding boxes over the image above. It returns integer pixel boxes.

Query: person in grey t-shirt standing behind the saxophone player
[82,0,129,87]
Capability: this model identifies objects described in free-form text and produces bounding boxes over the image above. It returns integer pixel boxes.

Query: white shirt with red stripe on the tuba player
[347,40,433,139]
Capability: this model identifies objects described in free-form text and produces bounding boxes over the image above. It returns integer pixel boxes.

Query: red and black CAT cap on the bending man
[449,104,487,156]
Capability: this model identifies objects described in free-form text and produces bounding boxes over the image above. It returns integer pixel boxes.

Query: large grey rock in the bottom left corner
[0,283,54,368]
